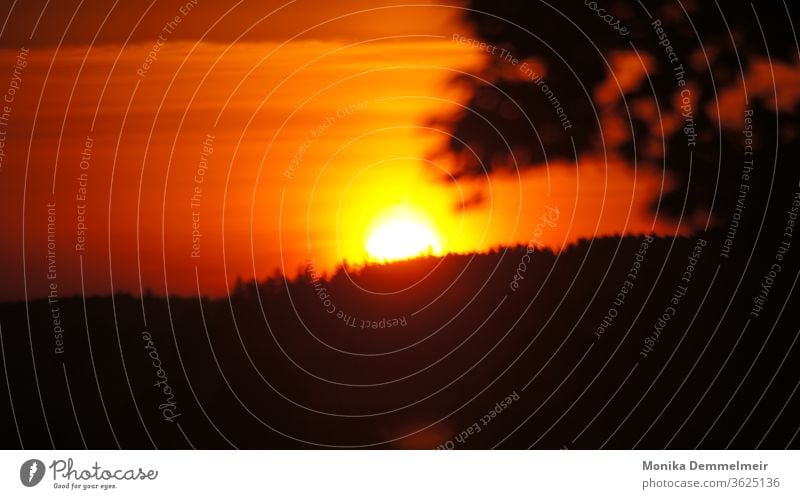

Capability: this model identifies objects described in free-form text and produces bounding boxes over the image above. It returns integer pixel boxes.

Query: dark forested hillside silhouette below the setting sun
[0,227,800,448]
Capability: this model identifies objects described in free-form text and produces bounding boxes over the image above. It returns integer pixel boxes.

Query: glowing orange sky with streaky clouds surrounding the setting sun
[0,1,673,299]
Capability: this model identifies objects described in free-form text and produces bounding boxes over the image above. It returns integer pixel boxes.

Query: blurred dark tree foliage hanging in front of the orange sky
[433,0,798,218]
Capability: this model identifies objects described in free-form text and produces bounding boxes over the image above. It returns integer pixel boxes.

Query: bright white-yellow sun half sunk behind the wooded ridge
[366,207,442,262]
